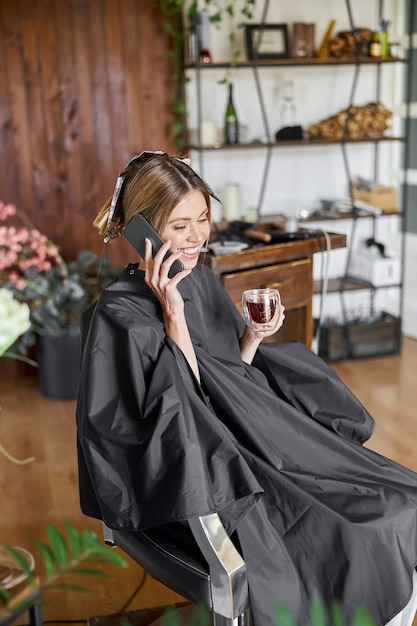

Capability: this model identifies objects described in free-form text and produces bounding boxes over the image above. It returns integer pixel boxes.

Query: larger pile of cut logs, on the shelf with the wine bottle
[305,102,392,141]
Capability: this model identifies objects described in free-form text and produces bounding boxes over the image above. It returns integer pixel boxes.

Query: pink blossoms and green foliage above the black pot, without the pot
[0,200,120,356]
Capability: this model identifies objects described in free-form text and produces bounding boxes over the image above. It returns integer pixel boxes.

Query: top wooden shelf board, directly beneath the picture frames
[185,56,408,70]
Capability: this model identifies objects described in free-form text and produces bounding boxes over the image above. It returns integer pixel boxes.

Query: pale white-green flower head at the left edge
[0,289,30,356]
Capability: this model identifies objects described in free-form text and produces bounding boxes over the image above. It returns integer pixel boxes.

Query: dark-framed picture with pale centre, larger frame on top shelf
[245,24,289,61]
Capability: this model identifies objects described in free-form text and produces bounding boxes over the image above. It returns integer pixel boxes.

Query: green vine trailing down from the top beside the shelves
[153,0,257,149]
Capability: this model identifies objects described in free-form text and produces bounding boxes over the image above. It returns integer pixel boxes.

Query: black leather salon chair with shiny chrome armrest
[103,513,250,626]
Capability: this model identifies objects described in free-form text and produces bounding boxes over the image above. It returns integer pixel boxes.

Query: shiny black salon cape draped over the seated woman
[77,265,417,626]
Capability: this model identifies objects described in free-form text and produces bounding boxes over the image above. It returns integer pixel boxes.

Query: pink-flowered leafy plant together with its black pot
[0,201,120,399]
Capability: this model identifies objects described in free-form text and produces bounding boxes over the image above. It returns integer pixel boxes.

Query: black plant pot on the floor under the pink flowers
[38,333,81,400]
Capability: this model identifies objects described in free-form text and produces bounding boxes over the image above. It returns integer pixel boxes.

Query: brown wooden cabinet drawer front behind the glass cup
[221,258,313,310]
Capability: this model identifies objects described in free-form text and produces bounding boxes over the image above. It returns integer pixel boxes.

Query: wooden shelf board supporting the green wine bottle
[187,135,404,151]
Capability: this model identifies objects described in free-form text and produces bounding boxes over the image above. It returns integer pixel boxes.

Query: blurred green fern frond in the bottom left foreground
[0,522,127,621]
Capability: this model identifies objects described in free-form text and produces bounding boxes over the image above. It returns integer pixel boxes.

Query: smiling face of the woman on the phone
[162,189,210,269]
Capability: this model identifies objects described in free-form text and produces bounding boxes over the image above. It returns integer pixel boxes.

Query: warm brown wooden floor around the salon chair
[0,338,417,624]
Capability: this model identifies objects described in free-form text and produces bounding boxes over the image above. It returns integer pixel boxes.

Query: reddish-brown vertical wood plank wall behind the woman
[0,0,177,263]
